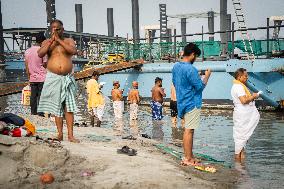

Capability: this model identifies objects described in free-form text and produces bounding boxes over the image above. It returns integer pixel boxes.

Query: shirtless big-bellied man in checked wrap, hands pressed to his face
[38,20,79,142]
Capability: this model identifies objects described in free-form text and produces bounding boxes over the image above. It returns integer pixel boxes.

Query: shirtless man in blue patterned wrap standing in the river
[150,77,166,120]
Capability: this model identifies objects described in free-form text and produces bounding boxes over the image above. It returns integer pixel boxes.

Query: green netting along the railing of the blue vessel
[87,39,284,60]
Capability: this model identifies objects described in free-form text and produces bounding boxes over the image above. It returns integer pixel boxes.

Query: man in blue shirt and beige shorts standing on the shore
[172,43,211,166]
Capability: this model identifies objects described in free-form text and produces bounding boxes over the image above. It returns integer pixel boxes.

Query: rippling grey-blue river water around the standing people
[0,85,284,188]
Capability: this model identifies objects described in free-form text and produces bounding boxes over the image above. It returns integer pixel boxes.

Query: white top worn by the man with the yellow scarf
[231,84,255,110]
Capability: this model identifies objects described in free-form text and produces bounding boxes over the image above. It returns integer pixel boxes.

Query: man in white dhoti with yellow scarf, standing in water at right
[231,68,260,161]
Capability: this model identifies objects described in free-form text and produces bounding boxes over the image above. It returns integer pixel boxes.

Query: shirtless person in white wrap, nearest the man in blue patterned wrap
[128,81,140,120]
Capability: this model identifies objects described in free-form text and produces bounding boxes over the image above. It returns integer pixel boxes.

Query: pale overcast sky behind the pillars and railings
[1,0,284,40]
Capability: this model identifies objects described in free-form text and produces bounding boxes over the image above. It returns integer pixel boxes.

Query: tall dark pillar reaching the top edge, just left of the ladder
[220,0,228,55]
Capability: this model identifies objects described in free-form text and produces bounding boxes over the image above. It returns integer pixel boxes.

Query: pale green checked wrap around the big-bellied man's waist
[37,71,77,117]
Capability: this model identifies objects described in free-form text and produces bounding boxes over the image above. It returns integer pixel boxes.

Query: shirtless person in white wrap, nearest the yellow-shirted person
[111,81,124,119]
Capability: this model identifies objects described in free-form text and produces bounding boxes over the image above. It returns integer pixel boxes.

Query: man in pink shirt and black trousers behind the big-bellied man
[25,33,47,115]
